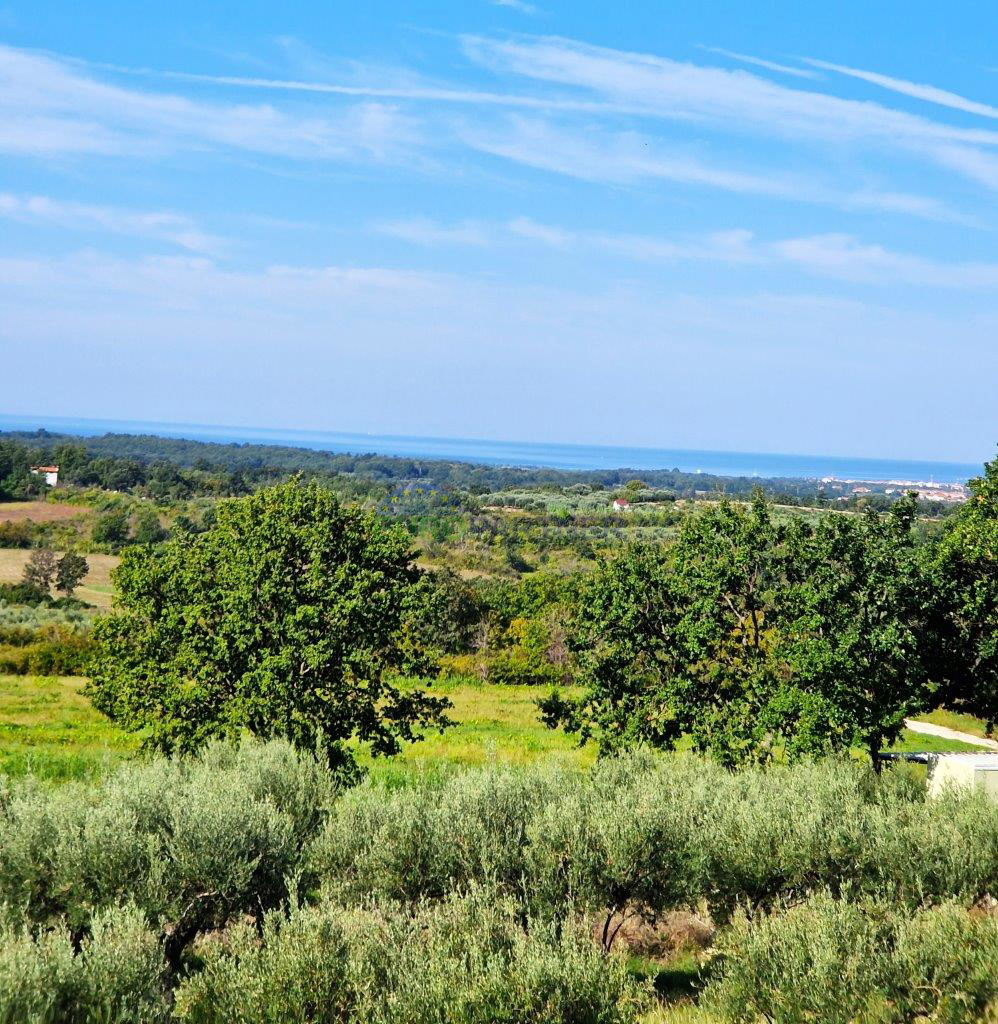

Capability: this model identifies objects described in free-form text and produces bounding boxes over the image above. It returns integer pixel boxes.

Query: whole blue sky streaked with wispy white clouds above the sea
[0,0,998,461]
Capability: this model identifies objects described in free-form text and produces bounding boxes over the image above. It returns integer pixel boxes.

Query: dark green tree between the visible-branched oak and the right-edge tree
[782,497,944,765]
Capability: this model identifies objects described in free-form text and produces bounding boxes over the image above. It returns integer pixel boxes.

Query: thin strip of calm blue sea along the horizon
[0,415,982,483]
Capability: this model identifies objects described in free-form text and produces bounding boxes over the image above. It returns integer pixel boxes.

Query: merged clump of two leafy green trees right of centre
[541,491,937,765]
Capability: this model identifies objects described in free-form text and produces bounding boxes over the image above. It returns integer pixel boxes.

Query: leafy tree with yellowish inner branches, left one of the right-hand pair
[541,499,781,764]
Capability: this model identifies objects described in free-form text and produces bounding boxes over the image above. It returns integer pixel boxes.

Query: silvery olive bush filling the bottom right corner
[707,895,998,1024]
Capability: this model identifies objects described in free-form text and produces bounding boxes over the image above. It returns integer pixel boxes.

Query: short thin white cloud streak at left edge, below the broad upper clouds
[0,193,228,253]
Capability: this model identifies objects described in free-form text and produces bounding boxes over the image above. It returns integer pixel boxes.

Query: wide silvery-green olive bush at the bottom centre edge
[177,890,647,1024]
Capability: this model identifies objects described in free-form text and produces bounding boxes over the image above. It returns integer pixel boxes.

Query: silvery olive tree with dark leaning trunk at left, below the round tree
[0,742,337,966]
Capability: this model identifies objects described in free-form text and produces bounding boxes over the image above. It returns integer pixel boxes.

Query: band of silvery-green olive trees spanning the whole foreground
[0,742,998,1024]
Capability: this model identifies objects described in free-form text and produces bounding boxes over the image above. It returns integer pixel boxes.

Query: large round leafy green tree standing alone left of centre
[89,480,447,765]
